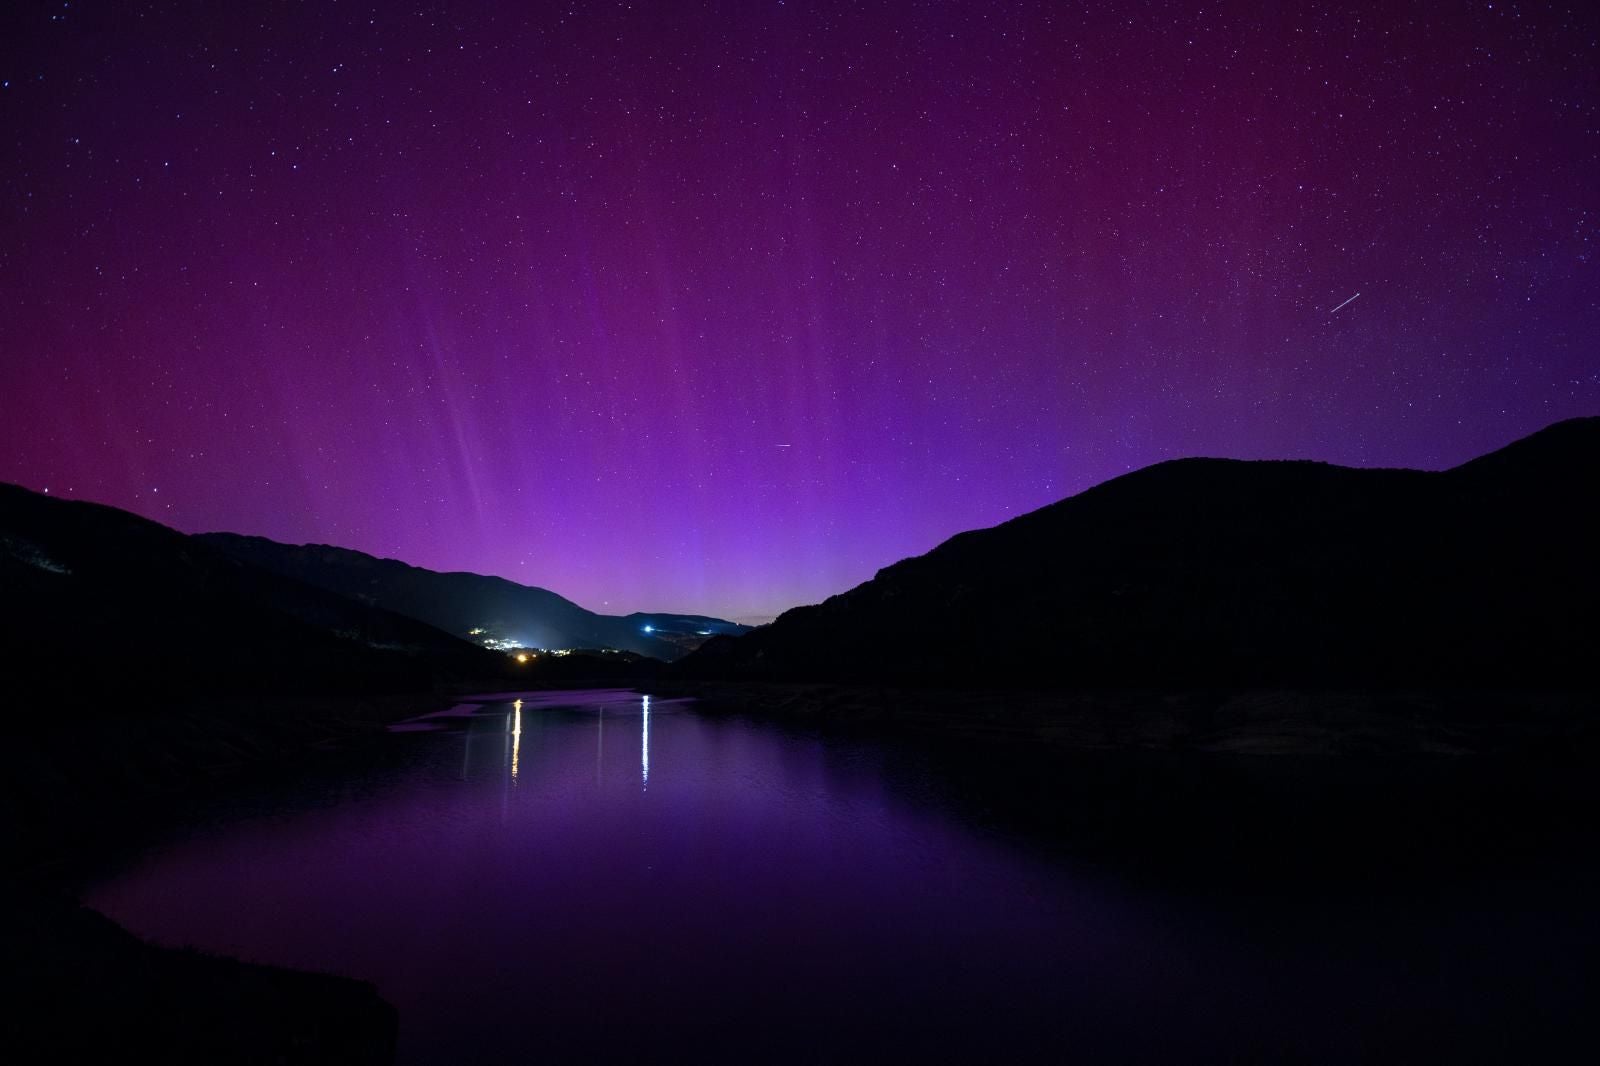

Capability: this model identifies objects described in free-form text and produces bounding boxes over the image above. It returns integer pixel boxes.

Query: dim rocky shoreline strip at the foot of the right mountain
[637,679,1600,757]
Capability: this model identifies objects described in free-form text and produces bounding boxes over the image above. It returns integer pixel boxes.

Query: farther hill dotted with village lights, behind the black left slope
[195,533,749,661]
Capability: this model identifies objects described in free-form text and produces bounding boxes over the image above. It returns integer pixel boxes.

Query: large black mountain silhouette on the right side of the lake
[678,418,1600,688]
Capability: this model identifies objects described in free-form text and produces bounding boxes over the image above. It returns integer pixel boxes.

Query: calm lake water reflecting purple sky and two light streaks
[88,691,1600,1063]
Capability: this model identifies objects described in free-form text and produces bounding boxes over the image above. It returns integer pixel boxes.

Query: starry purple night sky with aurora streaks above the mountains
[0,0,1600,618]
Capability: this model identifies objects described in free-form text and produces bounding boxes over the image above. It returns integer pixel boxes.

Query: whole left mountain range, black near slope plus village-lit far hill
[0,483,746,701]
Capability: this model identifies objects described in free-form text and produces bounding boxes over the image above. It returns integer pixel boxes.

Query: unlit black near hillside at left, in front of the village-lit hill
[0,483,506,706]
